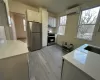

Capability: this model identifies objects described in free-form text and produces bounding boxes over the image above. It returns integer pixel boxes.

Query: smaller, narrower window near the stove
[58,16,67,35]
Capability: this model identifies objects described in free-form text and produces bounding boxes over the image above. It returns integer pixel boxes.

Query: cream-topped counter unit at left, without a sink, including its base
[0,40,29,80]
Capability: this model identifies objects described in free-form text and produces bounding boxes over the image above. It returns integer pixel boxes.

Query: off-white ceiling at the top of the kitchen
[13,0,91,14]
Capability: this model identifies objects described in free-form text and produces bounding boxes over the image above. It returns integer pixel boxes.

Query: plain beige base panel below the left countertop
[0,54,29,80]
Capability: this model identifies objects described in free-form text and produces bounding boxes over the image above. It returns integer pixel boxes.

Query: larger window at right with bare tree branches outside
[77,7,100,40]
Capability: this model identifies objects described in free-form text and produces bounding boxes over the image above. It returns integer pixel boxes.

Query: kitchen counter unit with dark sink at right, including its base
[61,44,100,80]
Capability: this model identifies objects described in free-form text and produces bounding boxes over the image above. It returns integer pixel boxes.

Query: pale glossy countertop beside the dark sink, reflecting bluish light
[63,44,100,80]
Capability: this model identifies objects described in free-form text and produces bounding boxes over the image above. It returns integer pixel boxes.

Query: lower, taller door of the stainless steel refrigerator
[31,33,42,51]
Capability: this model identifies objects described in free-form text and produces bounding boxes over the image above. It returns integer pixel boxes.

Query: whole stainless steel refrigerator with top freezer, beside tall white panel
[27,21,42,51]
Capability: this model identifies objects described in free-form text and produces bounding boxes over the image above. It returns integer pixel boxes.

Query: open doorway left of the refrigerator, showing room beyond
[10,12,27,43]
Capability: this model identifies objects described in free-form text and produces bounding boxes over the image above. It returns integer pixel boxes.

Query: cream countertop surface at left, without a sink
[0,40,28,59]
